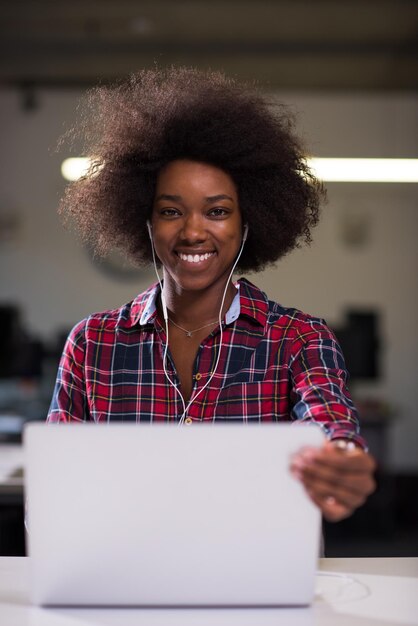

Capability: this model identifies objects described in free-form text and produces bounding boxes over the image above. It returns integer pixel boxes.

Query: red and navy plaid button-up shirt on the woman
[48,279,364,447]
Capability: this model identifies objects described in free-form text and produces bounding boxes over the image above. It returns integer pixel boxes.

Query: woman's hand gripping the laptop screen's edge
[290,441,376,522]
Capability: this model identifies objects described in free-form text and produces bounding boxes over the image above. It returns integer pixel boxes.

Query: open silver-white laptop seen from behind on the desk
[24,423,324,606]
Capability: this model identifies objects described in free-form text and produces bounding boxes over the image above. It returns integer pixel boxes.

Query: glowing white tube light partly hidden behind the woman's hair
[61,157,418,183]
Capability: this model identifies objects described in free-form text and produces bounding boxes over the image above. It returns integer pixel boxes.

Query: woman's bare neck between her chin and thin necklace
[164,281,237,328]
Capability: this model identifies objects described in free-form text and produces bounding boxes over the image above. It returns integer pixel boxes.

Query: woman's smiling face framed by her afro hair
[152,160,242,292]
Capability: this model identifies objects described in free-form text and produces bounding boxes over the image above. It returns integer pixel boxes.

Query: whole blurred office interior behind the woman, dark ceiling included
[0,0,418,556]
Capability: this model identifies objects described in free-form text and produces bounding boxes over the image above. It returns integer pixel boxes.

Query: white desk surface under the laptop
[0,557,418,626]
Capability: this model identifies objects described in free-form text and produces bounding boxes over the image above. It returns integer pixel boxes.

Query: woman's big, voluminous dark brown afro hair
[59,68,324,272]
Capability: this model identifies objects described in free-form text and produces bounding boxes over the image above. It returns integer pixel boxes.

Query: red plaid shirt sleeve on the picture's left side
[47,320,91,422]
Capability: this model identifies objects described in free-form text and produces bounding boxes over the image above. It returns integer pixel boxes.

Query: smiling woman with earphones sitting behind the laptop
[48,68,374,520]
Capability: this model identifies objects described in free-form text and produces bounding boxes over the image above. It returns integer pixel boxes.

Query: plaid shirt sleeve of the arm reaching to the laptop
[290,319,367,449]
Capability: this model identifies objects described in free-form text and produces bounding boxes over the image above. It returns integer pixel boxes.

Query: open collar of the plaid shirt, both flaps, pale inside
[129,278,268,326]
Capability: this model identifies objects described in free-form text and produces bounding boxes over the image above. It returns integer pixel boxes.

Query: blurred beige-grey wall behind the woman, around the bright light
[0,89,418,470]
